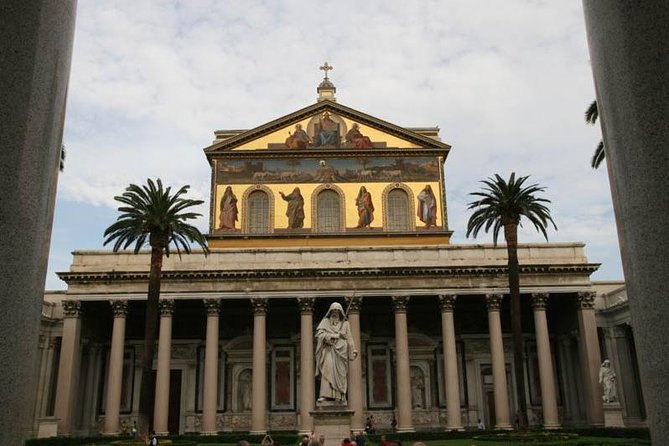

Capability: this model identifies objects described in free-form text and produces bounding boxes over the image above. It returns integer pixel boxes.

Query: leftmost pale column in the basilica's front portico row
[54,300,81,435]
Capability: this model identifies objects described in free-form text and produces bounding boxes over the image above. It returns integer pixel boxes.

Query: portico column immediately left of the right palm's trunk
[486,294,522,429]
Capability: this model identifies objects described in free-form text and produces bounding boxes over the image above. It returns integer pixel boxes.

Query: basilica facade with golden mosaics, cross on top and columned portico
[30,72,643,435]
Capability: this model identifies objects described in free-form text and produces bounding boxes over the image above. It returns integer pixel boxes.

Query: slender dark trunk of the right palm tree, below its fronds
[504,223,527,430]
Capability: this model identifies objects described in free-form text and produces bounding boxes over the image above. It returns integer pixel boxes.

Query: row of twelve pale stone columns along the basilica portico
[55,293,603,435]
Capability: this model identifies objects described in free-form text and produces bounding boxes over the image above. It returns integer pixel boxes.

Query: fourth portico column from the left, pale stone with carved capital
[200,299,221,435]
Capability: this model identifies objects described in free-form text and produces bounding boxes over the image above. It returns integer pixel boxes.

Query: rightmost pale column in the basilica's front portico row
[577,291,604,426]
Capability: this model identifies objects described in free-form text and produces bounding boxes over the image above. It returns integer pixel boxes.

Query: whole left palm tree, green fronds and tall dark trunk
[104,179,209,437]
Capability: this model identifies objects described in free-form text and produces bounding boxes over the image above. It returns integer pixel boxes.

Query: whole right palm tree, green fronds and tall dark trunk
[467,173,557,430]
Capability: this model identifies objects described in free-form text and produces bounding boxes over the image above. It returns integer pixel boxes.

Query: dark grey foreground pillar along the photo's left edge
[0,0,77,445]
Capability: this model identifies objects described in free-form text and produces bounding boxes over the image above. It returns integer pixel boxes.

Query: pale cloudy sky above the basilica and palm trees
[46,0,623,289]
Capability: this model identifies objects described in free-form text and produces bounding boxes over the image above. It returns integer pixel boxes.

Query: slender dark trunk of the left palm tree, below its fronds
[138,246,163,438]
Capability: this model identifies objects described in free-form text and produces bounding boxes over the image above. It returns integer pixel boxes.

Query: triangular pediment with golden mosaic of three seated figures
[205,100,450,156]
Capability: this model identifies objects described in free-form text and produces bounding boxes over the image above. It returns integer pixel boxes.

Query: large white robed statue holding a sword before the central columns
[316,302,358,402]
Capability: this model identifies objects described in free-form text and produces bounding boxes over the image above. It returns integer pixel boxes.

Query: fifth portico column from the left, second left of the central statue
[250,298,267,435]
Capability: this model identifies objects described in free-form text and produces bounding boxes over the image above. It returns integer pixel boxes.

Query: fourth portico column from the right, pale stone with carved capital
[439,294,463,430]
